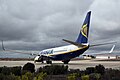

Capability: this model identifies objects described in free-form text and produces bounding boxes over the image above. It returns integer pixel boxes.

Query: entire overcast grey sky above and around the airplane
[0,0,120,57]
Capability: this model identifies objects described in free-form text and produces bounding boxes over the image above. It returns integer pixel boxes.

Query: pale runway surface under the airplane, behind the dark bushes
[0,60,120,70]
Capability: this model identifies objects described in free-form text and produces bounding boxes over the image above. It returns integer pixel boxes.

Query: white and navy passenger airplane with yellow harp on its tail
[2,11,113,64]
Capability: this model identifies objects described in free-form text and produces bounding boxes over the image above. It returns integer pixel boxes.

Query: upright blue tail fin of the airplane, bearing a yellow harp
[76,11,91,44]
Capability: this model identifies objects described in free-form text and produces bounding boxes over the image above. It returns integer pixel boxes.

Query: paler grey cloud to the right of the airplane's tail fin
[86,0,120,52]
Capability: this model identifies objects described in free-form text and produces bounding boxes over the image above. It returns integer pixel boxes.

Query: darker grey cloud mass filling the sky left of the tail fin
[0,0,93,50]
